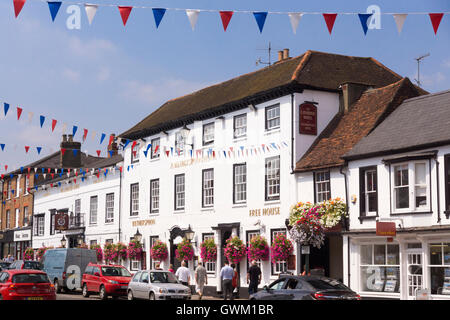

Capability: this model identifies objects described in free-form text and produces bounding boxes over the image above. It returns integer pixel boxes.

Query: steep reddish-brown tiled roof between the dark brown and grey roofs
[295,78,422,172]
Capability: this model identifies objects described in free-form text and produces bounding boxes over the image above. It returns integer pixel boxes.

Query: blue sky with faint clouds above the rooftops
[0,0,450,173]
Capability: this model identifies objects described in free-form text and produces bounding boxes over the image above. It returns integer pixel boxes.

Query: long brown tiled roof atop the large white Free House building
[119,50,414,139]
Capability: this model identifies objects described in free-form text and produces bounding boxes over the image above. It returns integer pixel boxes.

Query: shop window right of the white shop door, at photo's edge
[429,242,450,295]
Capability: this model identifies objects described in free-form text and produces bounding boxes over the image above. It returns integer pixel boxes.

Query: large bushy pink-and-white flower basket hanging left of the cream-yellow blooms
[289,202,325,249]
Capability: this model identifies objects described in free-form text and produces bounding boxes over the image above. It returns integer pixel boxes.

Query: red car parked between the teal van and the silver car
[81,263,131,300]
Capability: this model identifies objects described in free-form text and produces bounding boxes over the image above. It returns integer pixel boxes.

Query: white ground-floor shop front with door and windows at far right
[349,230,450,300]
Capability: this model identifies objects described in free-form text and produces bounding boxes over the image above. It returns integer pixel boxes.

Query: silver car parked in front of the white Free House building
[127,270,191,300]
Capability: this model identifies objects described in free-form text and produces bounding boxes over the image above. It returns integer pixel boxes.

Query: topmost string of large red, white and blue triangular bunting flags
[7,0,450,35]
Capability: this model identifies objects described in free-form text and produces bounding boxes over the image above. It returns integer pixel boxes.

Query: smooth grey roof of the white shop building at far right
[345,90,450,160]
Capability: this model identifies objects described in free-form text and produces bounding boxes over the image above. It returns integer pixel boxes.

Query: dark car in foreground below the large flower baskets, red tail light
[250,275,361,300]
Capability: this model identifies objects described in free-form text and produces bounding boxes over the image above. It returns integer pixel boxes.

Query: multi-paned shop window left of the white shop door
[360,244,400,293]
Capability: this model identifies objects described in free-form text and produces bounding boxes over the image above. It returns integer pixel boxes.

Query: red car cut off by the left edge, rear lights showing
[0,270,56,300]
